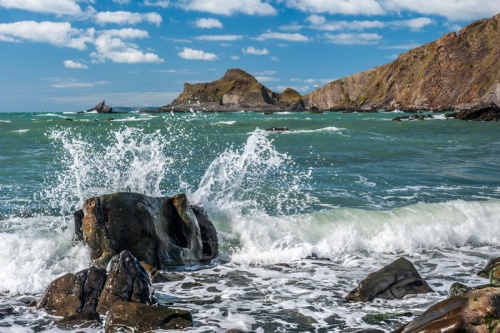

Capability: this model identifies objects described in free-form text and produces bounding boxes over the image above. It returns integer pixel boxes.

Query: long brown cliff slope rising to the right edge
[303,14,500,110]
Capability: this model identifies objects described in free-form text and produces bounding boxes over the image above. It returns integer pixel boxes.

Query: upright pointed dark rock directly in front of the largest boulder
[97,251,155,314]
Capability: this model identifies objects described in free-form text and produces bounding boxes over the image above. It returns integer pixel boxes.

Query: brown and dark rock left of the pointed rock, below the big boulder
[37,266,106,316]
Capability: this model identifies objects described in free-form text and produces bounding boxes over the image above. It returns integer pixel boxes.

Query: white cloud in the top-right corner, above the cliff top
[381,0,500,21]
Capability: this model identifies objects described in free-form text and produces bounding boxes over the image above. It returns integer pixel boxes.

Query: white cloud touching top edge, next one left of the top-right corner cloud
[286,0,384,15]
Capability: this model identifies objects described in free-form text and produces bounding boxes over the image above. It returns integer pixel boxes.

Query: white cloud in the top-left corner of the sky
[0,0,82,15]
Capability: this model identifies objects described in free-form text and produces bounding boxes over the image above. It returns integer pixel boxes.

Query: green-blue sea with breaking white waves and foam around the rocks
[0,110,500,333]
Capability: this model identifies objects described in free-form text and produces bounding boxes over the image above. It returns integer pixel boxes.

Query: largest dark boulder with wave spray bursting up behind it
[82,192,218,269]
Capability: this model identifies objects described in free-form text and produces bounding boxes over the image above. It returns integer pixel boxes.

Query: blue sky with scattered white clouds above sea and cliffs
[0,0,500,112]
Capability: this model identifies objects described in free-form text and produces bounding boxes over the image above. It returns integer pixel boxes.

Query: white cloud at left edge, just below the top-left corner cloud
[0,21,94,50]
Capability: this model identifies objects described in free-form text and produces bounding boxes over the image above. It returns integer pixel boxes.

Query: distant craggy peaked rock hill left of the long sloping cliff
[157,69,304,112]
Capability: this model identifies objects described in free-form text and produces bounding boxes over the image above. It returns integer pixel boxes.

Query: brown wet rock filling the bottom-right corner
[393,288,500,333]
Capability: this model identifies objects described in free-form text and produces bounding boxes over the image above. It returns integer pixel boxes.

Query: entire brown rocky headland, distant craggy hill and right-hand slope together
[147,14,500,120]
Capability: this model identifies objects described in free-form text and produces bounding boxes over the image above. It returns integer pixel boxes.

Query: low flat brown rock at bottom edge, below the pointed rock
[105,302,193,333]
